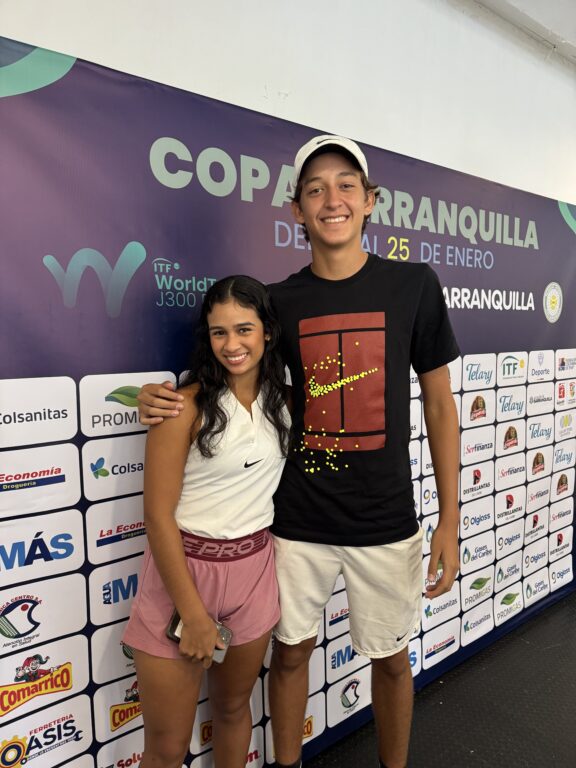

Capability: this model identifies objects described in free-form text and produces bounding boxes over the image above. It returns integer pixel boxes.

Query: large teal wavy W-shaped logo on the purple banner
[42,240,146,317]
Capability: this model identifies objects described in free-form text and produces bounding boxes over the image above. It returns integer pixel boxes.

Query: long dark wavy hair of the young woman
[181,275,290,458]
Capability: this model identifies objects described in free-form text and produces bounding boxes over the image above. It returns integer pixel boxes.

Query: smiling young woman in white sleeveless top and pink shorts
[123,276,290,768]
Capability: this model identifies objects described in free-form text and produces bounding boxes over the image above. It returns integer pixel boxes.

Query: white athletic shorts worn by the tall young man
[274,530,423,659]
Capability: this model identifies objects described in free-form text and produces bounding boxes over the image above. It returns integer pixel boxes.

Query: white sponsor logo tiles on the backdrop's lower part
[0,350,576,766]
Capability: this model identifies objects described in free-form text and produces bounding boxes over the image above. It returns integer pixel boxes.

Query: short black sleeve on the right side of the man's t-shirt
[410,265,460,373]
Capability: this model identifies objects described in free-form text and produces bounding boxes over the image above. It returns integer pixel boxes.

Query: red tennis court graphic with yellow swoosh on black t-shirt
[299,312,386,464]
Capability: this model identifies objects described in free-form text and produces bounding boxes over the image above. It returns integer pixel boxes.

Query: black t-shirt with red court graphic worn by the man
[270,254,459,546]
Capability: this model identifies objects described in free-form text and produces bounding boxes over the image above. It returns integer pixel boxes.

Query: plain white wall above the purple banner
[0,0,576,203]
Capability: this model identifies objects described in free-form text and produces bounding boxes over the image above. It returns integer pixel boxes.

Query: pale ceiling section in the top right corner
[476,0,576,65]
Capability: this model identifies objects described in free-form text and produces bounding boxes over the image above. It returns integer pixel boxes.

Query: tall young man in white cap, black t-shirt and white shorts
[140,136,459,768]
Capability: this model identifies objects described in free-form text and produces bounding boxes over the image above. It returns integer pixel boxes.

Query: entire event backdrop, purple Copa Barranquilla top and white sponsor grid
[0,39,576,768]
